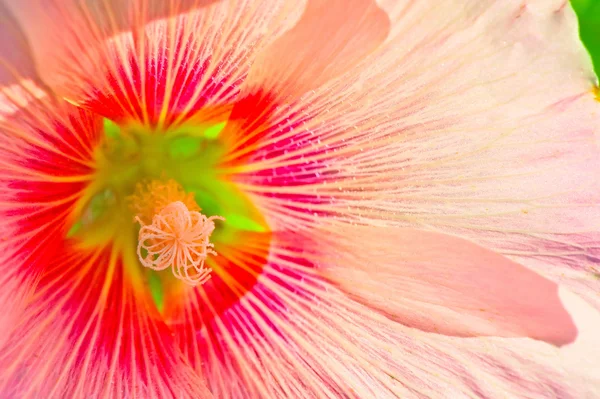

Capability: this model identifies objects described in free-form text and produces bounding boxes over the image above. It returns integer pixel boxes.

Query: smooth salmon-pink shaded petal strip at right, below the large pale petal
[317,227,577,345]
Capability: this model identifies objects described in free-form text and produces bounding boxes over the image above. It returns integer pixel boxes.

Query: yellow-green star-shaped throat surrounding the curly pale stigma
[67,119,268,282]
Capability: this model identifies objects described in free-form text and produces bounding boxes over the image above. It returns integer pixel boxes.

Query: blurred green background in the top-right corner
[571,0,600,76]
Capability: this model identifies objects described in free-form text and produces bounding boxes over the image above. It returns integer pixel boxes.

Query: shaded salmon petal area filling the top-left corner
[0,0,216,93]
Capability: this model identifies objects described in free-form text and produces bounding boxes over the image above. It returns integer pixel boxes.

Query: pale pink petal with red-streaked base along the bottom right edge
[169,245,600,399]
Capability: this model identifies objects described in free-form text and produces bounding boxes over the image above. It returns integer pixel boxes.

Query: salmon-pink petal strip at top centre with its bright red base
[217,0,390,164]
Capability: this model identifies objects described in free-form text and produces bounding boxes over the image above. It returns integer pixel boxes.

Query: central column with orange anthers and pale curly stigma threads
[129,180,225,286]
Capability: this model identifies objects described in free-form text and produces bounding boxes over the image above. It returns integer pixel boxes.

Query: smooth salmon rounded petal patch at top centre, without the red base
[246,0,390,97]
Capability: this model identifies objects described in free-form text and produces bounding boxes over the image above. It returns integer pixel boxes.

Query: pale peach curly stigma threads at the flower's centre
[136,201,225,285]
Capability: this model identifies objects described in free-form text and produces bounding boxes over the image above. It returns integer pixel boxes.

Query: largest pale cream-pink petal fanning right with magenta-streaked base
[238,0,600,309]
